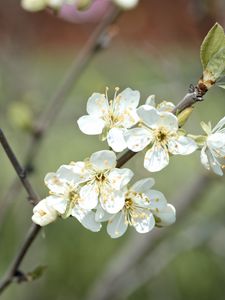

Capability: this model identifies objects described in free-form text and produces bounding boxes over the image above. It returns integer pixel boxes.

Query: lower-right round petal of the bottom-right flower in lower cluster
[132,209,155,233]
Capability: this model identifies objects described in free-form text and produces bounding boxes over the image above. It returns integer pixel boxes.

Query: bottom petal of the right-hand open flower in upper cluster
[144,145,169,172]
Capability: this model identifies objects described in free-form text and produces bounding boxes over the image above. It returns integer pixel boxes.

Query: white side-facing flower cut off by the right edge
[201,117,225,176]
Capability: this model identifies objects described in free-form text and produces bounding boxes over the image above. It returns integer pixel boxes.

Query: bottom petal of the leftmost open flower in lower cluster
[72,206,102,232]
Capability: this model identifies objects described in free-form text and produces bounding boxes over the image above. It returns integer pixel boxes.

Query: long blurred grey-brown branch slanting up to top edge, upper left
[0,6,120,224]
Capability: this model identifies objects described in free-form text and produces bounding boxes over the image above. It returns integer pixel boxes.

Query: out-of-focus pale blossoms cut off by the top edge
[21,0,139,11]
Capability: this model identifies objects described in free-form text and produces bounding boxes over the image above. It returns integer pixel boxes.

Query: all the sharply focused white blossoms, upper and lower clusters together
[32,88,225,238]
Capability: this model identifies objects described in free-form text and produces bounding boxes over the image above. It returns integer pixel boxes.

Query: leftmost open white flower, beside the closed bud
[32,165,101,232]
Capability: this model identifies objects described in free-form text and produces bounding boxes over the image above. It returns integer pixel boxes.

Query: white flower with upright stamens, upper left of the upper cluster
[77,88,140,152]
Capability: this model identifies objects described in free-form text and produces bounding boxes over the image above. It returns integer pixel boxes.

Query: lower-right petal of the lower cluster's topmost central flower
[100,190,125,214]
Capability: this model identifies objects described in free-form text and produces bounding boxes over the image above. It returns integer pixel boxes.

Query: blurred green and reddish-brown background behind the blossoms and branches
[0,0,225,300]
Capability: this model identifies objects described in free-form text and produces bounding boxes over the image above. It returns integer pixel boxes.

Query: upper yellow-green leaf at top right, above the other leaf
[200,23,225,69]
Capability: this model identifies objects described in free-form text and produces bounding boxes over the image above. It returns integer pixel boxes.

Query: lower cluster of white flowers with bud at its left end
[32,150,175,238]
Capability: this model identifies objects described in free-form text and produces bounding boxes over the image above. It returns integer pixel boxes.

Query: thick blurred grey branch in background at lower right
[86,175,214,300]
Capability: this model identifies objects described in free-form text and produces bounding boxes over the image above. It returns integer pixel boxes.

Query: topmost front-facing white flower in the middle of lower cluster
[73,150,133,214]
